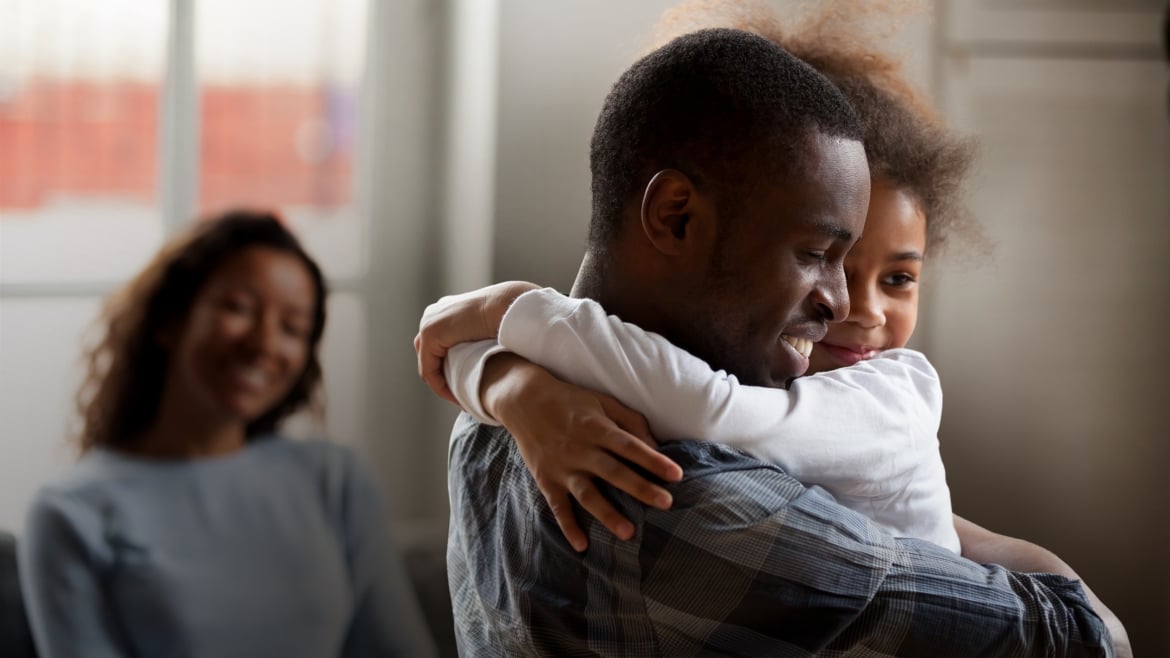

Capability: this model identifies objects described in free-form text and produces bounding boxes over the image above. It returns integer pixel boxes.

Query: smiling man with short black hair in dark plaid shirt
[439,30,1112,656]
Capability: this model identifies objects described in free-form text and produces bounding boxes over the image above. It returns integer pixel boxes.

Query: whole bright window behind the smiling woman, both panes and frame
[0,0,369,530]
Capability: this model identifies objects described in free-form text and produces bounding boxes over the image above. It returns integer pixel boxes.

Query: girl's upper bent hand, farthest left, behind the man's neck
[414,281,539,404]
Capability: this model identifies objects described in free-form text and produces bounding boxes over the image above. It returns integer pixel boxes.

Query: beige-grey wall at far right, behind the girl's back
[923,1,1170,656]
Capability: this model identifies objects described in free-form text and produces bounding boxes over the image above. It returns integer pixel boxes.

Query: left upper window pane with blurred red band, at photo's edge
[0,0,168,285]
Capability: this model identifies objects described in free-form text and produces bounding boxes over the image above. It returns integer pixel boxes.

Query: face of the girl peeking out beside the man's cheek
[808,178,927,372]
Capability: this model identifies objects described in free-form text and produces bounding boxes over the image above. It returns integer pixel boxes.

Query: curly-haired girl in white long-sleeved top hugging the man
[415,2,1128,646]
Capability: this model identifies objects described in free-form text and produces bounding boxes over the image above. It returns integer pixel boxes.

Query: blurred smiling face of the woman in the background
[165,247,317,424]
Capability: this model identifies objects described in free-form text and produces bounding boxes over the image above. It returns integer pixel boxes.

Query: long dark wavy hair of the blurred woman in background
[77,210,325,452]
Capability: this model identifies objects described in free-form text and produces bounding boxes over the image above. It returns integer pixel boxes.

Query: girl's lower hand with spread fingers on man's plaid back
[480,354,682,550]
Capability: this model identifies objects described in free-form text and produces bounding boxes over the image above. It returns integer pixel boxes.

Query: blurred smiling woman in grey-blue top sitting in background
[20,212,433,658]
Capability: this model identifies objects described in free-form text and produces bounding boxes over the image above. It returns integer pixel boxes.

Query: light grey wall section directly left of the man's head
[494,0,676,290]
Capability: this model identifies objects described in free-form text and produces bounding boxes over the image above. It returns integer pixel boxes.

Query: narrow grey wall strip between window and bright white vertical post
[358,0,449,526]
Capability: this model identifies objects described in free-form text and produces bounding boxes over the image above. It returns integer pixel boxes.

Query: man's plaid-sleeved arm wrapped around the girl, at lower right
[641,443,1113,657]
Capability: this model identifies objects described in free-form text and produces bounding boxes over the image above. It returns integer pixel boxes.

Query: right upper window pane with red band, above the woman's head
[194,0,366,277]
